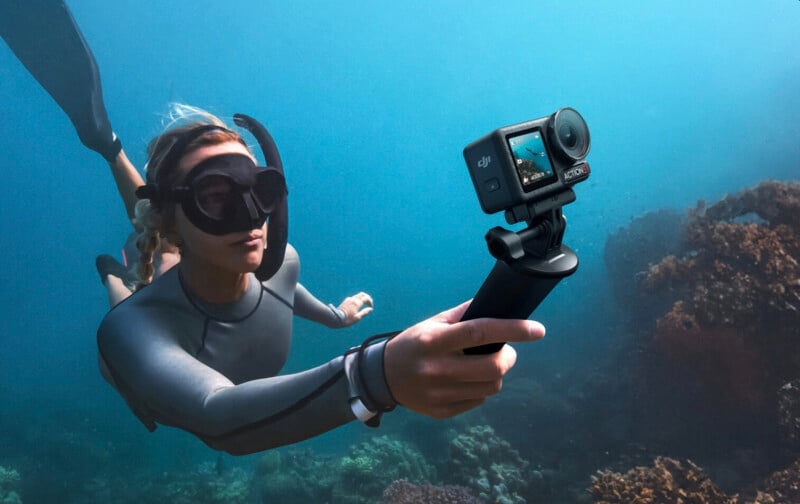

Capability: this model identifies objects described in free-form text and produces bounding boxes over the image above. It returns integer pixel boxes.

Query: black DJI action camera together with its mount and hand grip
[461,108,590,354]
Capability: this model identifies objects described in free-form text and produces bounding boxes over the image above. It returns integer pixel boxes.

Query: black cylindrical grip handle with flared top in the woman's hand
[461,245,578,355]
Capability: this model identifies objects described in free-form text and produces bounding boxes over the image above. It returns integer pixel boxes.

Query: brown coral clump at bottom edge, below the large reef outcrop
[589,457,735,504]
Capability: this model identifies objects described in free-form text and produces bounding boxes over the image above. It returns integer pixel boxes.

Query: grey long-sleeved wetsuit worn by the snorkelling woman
[97,246,395,454]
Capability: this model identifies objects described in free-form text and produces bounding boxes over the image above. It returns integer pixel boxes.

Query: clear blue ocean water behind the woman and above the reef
[0,0,800,502]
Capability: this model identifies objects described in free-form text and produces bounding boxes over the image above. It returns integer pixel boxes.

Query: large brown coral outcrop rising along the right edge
[643,182,800,411]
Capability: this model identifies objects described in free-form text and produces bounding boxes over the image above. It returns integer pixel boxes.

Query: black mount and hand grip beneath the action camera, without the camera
[461,189,578,355]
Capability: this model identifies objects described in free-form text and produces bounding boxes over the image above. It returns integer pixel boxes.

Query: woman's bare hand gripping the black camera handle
[384,302,545,418]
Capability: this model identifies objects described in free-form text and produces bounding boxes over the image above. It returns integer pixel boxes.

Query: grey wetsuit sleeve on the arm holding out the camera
[98,311,394,455]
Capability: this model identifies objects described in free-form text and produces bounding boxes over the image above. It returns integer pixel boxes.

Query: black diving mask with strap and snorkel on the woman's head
[136,114,289,282]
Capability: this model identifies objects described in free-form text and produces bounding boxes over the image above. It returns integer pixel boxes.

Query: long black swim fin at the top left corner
[0,0,121,161]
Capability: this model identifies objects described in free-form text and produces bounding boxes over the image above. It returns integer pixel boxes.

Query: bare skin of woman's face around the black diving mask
[175,142,267,273]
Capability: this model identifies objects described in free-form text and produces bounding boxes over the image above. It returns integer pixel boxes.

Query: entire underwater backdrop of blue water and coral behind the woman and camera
[0,0,800,503]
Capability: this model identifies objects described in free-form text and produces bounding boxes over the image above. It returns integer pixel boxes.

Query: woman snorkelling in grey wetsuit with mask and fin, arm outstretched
[0,0,544,454]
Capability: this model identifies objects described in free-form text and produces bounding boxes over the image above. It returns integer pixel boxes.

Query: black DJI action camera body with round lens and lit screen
[464,107,591,224]
